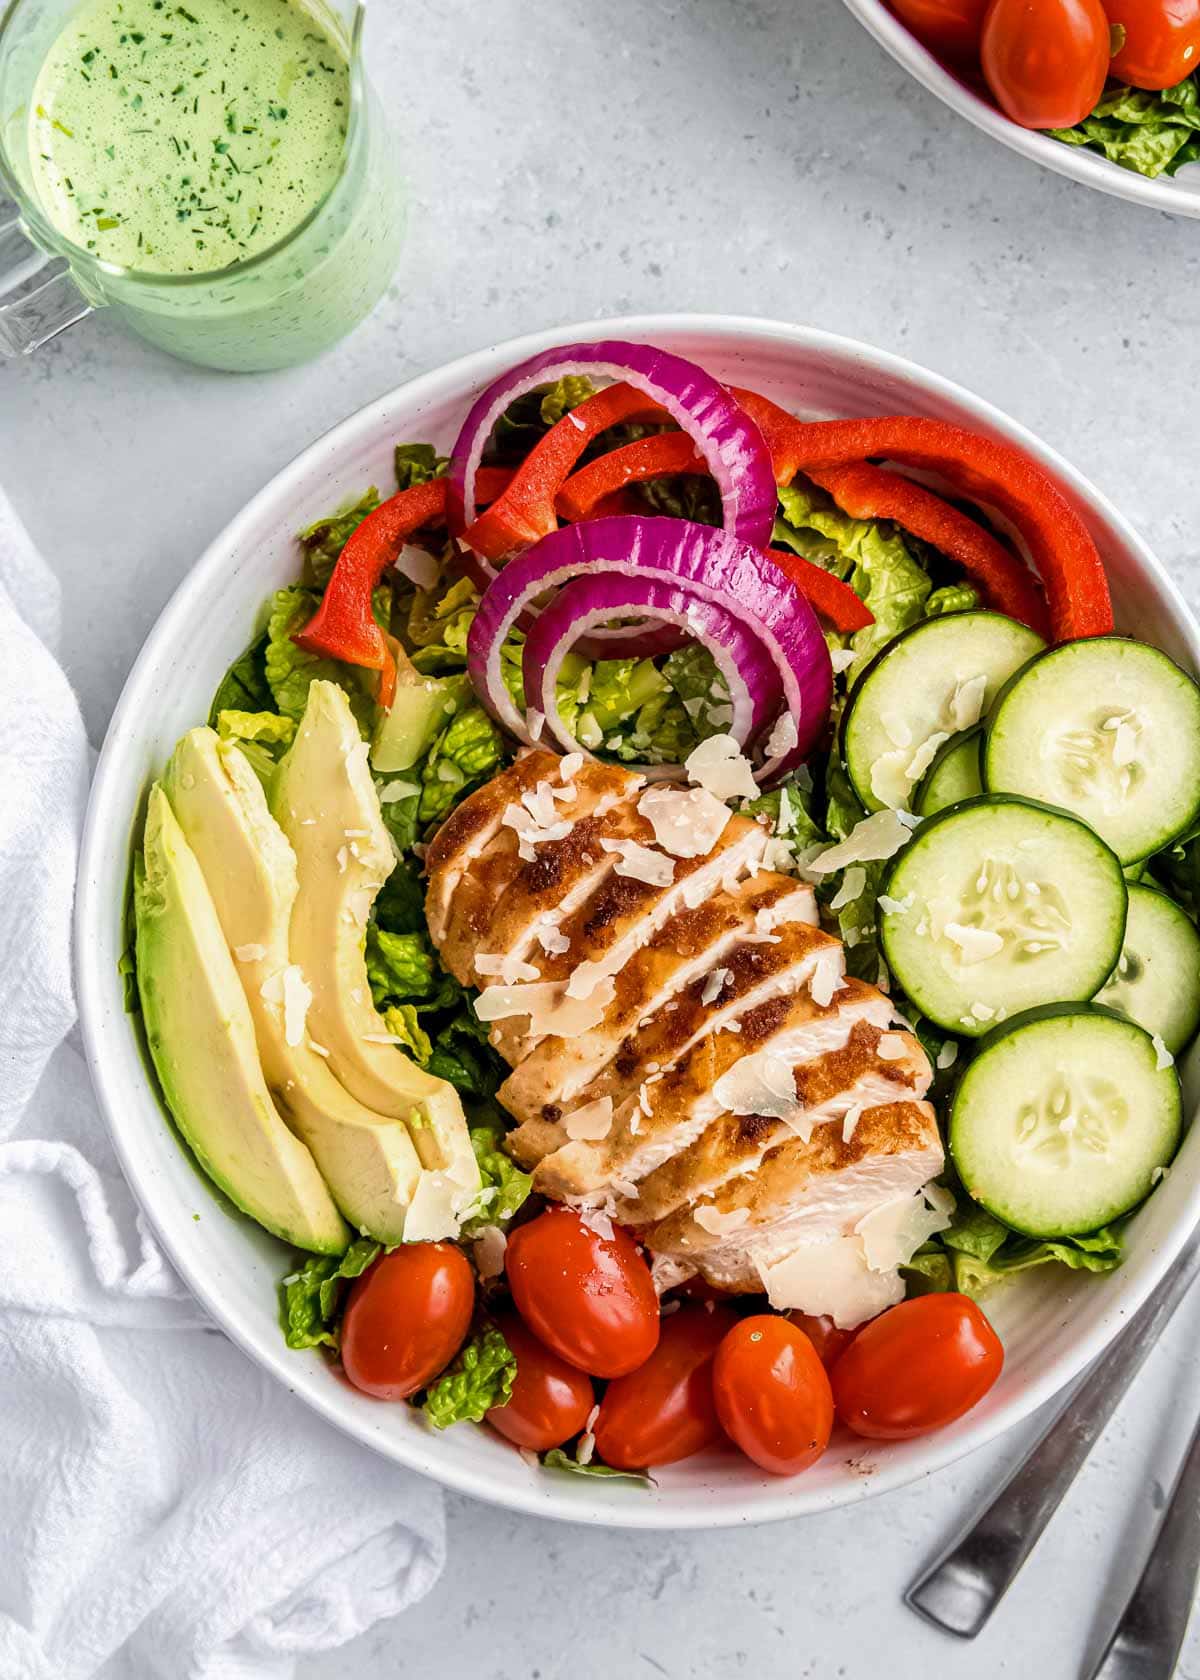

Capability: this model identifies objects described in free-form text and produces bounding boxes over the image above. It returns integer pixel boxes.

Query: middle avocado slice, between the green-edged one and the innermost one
[163,729,420,1245]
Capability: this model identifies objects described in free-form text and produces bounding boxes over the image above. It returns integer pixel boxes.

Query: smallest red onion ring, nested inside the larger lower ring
[523,571,783,774]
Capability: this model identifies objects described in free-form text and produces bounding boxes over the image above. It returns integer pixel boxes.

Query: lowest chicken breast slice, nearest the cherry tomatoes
[639,1102,945,1294]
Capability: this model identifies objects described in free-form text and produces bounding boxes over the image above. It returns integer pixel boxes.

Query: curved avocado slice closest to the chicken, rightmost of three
[271,680,479,1235]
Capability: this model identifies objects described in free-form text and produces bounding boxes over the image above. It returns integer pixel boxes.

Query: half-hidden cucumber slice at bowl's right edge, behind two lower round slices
[1096,885,1200,1055]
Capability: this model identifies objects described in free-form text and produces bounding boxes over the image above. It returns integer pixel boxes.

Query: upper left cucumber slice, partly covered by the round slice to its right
[842,613,1045,811]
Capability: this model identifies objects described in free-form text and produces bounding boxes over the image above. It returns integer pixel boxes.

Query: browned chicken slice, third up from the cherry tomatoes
[534,979,903,1202]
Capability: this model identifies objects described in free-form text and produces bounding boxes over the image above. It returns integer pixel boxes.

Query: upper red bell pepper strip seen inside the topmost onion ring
[461,385,662,561]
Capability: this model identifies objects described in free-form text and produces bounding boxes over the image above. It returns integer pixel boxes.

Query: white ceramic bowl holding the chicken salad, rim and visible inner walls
[76,316,1200,1527]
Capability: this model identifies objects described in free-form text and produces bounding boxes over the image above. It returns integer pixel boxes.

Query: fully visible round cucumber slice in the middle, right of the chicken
[879,796,1126,1038]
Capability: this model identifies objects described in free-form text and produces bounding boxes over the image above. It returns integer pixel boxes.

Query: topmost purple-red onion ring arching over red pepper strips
[447,339,776,548]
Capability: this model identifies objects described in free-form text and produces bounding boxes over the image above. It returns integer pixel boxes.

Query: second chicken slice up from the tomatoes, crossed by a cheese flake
[621,1021,931,1225]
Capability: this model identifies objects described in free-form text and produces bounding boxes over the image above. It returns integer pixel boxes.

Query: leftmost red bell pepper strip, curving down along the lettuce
[292,467,513,709]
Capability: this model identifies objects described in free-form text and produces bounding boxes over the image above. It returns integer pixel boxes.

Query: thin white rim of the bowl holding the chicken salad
[74,312,1200,1529]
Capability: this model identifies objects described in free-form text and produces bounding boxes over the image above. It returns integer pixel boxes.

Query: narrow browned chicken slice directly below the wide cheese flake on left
[499,870,817,1122]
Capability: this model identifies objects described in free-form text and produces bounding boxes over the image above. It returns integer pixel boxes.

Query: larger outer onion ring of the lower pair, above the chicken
[467,516,834,781]
